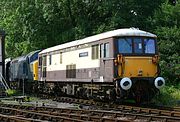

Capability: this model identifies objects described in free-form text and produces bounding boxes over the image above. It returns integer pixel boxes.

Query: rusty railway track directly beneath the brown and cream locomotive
[40,95,180,112]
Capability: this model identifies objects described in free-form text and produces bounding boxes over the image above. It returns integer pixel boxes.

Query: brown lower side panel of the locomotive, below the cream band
[39,68,113,83]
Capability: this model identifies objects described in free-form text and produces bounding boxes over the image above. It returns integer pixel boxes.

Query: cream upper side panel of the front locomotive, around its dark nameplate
[47,47,100,71]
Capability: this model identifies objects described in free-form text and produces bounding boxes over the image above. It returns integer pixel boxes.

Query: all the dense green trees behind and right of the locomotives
[0,0,180,105]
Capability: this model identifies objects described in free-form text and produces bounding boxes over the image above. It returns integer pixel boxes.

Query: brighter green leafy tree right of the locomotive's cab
[151,2,180,84]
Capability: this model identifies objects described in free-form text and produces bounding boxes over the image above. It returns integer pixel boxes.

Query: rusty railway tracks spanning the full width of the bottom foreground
[0,104,180,122]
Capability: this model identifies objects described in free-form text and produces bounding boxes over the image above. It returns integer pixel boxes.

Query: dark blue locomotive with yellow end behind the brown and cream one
[5,50,40,91]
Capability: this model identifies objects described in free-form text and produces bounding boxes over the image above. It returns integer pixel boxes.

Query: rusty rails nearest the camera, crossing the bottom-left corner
[0,106,86,122]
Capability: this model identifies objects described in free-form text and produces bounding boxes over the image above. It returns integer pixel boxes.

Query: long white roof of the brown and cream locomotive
[39,28,157,55]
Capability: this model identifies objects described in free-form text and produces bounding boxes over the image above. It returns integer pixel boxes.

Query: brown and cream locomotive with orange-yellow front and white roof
[6,28,165,102]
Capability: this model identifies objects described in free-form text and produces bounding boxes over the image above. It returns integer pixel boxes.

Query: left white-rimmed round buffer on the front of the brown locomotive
[120,77,132,90]
